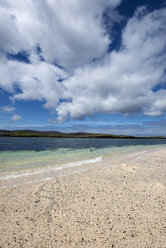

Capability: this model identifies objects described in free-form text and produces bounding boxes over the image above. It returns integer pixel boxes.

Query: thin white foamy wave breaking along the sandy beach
[0,156,102,180]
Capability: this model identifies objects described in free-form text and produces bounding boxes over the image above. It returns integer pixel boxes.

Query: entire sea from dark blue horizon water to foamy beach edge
[0,137,166,188]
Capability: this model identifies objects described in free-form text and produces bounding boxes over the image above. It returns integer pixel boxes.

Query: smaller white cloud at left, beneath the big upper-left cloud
[1,60,67,108]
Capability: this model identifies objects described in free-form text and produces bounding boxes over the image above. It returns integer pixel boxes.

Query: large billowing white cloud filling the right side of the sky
[57,5,166,121]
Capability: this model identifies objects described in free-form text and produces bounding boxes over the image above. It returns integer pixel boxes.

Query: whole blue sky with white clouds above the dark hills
[0,0,166,136]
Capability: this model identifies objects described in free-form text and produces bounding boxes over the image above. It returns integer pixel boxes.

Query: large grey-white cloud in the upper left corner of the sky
[0,0,121,66]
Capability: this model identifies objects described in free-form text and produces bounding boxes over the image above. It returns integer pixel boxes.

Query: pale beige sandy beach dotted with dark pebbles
[0,148,166,248]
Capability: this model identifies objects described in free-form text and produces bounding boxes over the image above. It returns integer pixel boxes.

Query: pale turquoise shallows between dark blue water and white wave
[0,141,165,173]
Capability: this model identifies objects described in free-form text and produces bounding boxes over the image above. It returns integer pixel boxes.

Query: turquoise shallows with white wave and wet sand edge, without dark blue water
[0,144,166,188]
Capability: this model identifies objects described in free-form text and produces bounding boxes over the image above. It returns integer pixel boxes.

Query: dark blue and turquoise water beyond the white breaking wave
[0,137,166,174]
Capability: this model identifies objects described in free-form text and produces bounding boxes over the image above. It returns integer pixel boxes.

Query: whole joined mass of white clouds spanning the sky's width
[0,0,166,122]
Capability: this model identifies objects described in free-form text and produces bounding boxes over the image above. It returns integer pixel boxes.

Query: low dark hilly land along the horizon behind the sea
[0,130,166,139]
